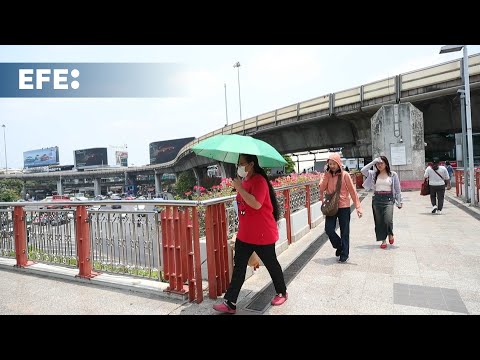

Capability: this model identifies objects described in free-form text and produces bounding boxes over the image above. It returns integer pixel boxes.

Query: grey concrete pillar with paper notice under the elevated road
[371,103,425,181]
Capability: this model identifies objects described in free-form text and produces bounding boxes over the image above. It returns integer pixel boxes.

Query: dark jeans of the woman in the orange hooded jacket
[325,207,350,260]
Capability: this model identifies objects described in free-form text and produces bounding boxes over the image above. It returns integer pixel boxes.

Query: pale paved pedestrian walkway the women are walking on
[0,191,480,316]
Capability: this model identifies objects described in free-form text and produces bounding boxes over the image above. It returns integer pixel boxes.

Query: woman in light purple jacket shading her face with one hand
[360,156,403,249]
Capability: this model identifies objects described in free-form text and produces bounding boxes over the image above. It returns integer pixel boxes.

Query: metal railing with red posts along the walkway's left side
[0,180,326,302]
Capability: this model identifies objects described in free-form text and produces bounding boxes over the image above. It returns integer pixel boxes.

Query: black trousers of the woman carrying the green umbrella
[224,238,287,303]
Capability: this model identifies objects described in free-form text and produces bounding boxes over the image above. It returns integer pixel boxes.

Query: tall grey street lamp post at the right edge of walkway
[440,45,475,205]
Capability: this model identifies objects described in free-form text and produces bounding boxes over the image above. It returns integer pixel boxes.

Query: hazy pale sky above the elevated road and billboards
[0,45,480,168]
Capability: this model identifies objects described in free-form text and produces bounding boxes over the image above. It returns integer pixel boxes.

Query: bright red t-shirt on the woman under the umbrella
[237,174,278,245]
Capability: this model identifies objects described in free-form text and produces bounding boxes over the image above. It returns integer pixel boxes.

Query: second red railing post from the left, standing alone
[75,205,98,279]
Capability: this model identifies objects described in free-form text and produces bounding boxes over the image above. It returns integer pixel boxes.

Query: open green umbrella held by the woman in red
[192,134,287,168]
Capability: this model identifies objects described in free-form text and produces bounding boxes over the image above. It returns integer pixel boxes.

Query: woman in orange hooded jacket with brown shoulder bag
[320,153,363,263]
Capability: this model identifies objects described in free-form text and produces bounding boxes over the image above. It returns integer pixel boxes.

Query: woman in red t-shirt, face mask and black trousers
[213,154,288,314]
